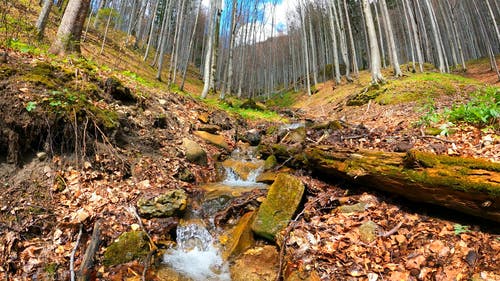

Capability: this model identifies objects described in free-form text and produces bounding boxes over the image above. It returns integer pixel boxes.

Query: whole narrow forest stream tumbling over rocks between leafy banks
[159,147,268,281]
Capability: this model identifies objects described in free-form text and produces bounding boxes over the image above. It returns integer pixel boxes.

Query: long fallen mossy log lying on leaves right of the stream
[264,145,500,222]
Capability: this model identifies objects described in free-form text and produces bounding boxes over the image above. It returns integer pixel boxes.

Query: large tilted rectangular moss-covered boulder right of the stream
[252,174,304,240]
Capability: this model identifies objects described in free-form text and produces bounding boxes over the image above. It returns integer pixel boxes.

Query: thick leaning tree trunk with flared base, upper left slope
[50,0,90,55]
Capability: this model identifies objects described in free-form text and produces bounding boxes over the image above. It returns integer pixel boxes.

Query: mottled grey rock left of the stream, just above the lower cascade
[137,189,187,218]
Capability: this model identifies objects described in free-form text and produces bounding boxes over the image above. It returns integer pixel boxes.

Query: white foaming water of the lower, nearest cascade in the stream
[163,223,231,281]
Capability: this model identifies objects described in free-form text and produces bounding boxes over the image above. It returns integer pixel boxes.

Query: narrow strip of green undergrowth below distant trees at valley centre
[203,95,283,121]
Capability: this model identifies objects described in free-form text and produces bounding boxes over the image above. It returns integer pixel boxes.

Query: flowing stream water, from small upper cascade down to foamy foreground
[163,147,267,281]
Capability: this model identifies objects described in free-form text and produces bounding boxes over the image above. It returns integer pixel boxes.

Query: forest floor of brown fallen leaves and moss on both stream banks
[0,1,500,281]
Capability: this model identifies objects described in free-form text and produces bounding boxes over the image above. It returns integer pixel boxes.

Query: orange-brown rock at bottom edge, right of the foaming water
[231,246,279,281]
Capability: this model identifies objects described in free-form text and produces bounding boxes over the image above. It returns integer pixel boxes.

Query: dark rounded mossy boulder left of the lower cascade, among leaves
[103,231,150,266]
